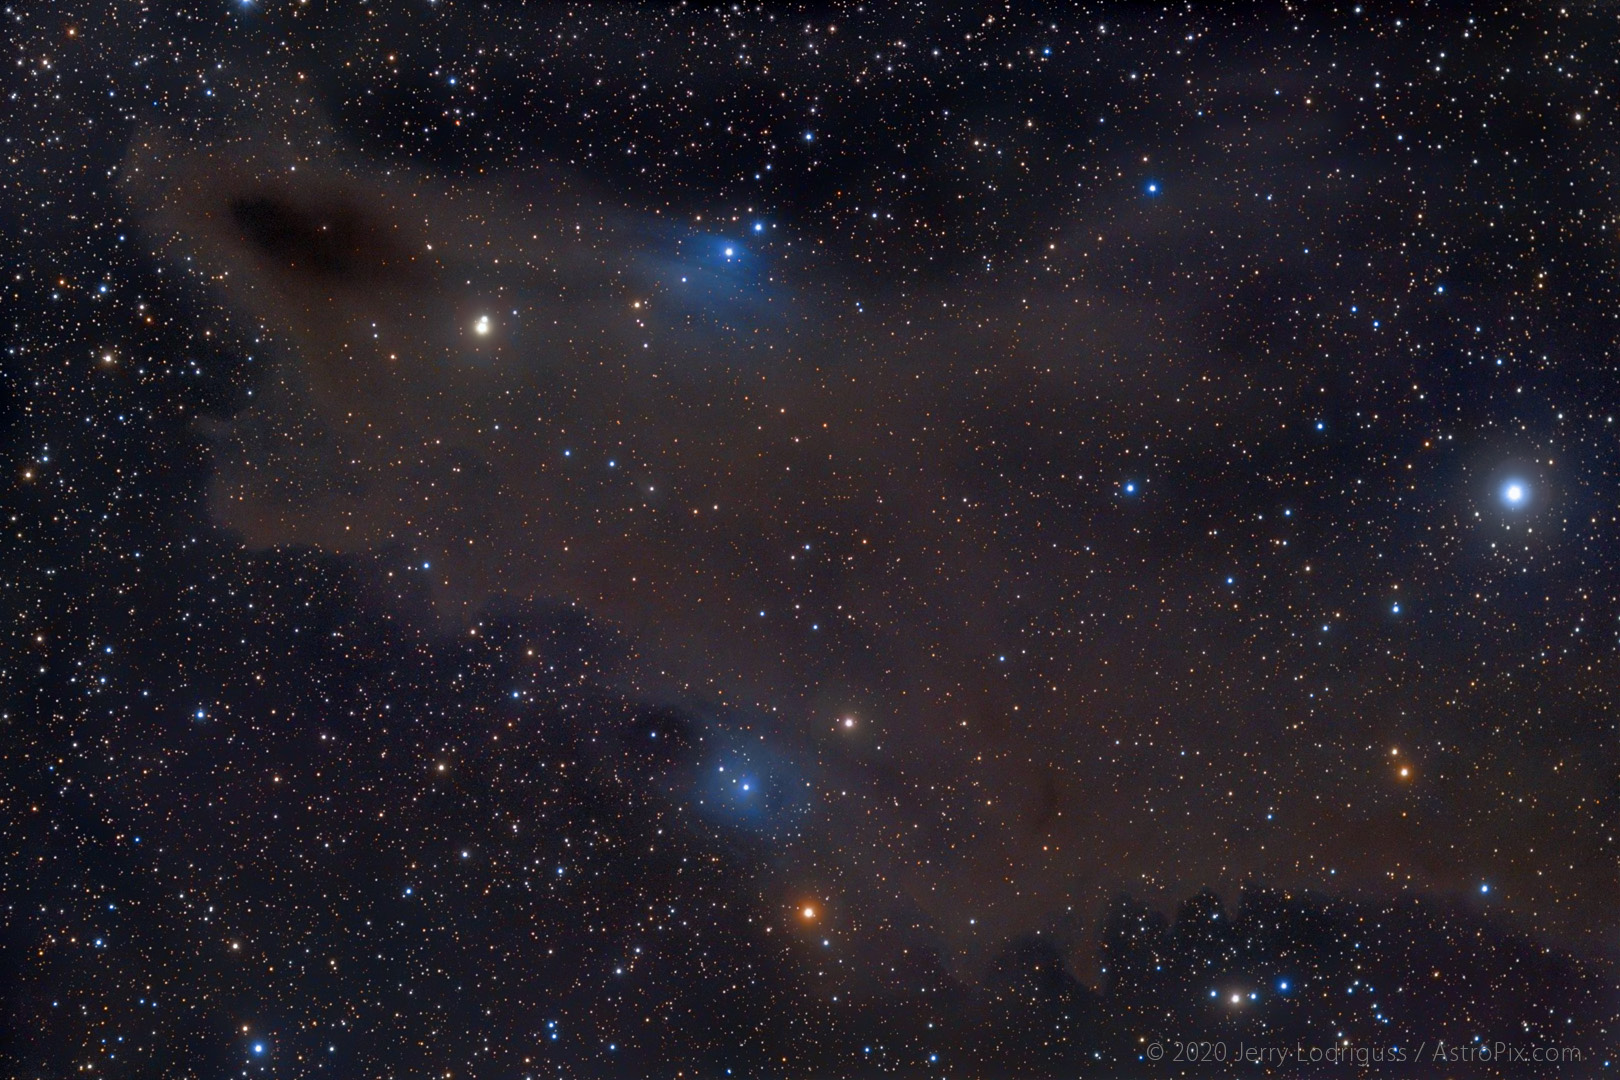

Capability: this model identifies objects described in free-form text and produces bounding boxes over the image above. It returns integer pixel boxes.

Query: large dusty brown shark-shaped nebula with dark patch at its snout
[123,110,1594,971]
